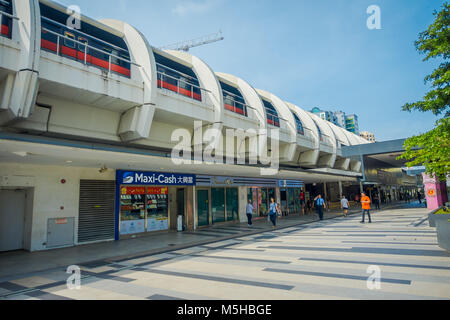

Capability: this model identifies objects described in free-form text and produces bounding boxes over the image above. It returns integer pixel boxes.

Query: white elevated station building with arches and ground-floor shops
[0,0,376,251]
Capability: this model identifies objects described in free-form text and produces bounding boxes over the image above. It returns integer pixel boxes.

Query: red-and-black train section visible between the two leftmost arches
[39,0,131,78]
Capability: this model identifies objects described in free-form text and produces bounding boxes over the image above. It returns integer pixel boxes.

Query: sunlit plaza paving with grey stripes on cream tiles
[0,202,450,300]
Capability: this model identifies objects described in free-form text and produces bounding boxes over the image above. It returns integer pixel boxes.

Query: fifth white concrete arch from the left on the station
[256,89,297,163]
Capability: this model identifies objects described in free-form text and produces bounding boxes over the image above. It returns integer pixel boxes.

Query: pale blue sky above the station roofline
[59,0,443,141]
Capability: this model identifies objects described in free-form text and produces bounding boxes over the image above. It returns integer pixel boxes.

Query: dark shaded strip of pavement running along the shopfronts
[0,205,370,282]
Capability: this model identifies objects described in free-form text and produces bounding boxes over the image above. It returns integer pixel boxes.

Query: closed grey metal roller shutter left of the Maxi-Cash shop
[78,180,116,243]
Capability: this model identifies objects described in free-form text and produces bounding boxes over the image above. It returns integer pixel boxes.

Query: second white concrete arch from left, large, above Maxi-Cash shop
[100,19,157,141]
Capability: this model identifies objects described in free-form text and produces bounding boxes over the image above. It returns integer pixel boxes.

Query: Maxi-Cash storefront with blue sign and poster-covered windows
[115,170,196,240]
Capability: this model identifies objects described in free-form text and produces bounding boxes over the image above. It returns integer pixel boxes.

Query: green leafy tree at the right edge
[398,2,450,180]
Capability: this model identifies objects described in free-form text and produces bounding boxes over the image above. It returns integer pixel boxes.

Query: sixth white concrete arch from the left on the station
[285,102,320,167]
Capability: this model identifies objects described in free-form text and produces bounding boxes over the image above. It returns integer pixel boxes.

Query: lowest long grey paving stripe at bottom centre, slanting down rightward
[135,268,294,291]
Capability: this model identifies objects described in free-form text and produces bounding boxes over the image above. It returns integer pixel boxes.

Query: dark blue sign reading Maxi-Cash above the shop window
[116,170,196,186]
